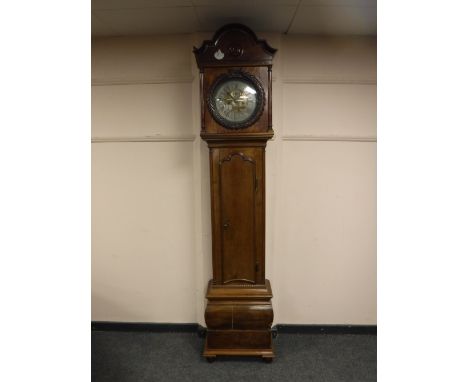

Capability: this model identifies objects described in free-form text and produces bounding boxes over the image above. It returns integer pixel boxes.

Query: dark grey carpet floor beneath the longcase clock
[91,331,377,382]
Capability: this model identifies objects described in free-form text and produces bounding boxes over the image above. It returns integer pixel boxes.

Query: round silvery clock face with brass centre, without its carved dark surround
[214,79,257,122]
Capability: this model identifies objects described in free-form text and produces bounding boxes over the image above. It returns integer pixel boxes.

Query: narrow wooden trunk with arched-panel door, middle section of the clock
[210,146,265,285]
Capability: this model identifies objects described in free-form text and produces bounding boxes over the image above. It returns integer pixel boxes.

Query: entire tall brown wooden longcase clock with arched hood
[194,24,276,361]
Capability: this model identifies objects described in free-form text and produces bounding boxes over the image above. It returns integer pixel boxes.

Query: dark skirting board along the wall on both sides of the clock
[91,321,377,337]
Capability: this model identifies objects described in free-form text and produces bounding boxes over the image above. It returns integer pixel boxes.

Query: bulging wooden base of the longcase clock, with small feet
[203,280,274,361]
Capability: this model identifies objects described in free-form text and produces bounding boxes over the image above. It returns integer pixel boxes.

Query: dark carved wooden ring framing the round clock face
[207,70,265,130]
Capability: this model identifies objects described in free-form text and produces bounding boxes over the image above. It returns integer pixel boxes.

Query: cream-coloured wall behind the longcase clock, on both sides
[92,34,376,324]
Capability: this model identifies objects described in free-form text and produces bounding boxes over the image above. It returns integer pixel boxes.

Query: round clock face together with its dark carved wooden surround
[208,71,265,129]
